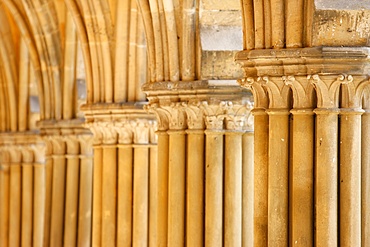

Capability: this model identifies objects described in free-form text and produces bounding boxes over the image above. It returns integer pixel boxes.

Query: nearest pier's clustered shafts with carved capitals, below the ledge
[241,75,369,246]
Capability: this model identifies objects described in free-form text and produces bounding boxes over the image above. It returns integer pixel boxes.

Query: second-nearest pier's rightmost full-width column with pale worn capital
[224,102,250,246]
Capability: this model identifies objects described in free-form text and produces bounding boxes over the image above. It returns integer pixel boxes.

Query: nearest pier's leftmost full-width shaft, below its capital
[268,112,289,247]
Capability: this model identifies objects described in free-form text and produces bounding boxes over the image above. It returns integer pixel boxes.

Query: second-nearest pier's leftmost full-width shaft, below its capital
[168,130,186,246]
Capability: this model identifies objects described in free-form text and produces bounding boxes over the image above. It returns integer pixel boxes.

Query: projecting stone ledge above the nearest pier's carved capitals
[235,47,370,77]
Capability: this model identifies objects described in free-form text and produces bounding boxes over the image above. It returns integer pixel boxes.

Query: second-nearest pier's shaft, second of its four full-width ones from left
[186,130,204,247]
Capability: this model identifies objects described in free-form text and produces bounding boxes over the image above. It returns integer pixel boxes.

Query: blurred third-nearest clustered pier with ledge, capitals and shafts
[85,105,156,246]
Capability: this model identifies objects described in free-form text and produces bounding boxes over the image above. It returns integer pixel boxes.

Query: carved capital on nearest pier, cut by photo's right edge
[341,75,369,109]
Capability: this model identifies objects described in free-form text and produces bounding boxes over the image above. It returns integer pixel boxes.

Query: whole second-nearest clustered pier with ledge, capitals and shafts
[144,81,253,246]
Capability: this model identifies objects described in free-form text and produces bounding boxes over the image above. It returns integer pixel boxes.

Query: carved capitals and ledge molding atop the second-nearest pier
[143,81,253,131]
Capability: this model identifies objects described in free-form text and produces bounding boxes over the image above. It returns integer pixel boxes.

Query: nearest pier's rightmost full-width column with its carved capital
[339,75,369,246]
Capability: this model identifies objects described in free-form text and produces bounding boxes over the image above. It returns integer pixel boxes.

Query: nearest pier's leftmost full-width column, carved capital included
[262,77,290,246]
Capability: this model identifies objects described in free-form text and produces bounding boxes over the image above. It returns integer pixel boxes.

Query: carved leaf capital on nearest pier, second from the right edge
[308,75,346,108]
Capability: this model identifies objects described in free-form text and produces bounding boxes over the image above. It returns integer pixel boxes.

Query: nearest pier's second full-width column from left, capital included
[282,76,315,246]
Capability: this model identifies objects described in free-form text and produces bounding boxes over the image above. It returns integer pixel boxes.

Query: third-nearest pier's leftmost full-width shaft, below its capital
[101,145,117,247]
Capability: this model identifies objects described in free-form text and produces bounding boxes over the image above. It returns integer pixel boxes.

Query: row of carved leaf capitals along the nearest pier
[238,74,369,109]
